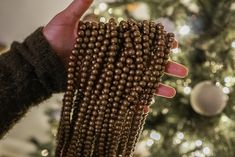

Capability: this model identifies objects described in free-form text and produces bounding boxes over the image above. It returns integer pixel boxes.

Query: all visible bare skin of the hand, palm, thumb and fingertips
[43,0,188,100]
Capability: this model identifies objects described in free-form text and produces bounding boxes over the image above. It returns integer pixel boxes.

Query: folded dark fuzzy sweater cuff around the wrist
[18,27,67,92]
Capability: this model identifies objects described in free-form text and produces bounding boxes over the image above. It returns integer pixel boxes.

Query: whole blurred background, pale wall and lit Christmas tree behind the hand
[0,0,235,157]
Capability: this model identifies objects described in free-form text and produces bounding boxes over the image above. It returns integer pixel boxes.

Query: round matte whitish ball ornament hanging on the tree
[190,81,228,116]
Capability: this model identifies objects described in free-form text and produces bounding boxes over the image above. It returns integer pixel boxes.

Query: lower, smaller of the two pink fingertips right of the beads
[155,83,176,98]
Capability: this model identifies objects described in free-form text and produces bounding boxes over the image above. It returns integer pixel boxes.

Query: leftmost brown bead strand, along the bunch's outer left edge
[55,22,84,157]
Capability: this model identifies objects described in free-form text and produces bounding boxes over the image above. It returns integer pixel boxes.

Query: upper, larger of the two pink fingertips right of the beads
[165,61,188,78]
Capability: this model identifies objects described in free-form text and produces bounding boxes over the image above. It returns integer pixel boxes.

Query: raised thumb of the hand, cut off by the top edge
[62,0,93,22]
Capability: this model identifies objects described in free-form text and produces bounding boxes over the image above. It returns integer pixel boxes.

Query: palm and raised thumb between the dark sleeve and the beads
[43,0,93,65]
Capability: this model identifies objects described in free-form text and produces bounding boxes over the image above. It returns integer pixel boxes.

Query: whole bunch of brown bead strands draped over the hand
[55,19,174,157]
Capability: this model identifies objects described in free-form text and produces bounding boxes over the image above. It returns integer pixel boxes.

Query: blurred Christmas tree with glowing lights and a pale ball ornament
[32,0,235,157]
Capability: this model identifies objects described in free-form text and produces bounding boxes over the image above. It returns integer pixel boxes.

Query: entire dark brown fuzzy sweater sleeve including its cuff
[0,28,66,138]
